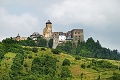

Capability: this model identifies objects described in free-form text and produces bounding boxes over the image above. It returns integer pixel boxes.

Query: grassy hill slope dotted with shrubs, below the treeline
[0,47,120,80]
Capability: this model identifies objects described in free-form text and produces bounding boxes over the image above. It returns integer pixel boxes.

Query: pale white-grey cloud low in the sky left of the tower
[0,8,39,37]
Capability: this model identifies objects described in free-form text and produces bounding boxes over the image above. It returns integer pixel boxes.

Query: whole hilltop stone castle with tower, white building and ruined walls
[13,20,84,48]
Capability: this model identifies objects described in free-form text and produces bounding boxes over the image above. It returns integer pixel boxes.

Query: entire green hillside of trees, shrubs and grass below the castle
[0,38,120,80]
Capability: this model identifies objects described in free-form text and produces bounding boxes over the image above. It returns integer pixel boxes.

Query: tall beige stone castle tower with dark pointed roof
[43,20,52,40]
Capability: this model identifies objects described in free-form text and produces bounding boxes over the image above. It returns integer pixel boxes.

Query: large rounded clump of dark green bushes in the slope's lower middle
[31,55,57,78]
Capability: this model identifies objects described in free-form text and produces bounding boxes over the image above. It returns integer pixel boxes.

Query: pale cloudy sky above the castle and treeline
[0,0,120,51]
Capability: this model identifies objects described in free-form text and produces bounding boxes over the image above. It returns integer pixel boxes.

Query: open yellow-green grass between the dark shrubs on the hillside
[0,47,120,80]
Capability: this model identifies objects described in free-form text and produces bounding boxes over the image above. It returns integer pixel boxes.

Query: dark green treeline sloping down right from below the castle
[57,37,120,60]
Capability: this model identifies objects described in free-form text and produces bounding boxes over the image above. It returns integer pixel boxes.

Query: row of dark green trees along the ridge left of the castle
[2,37,53,48]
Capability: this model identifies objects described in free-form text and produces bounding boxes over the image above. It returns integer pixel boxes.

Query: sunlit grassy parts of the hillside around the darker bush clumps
[0,47,120,80]
